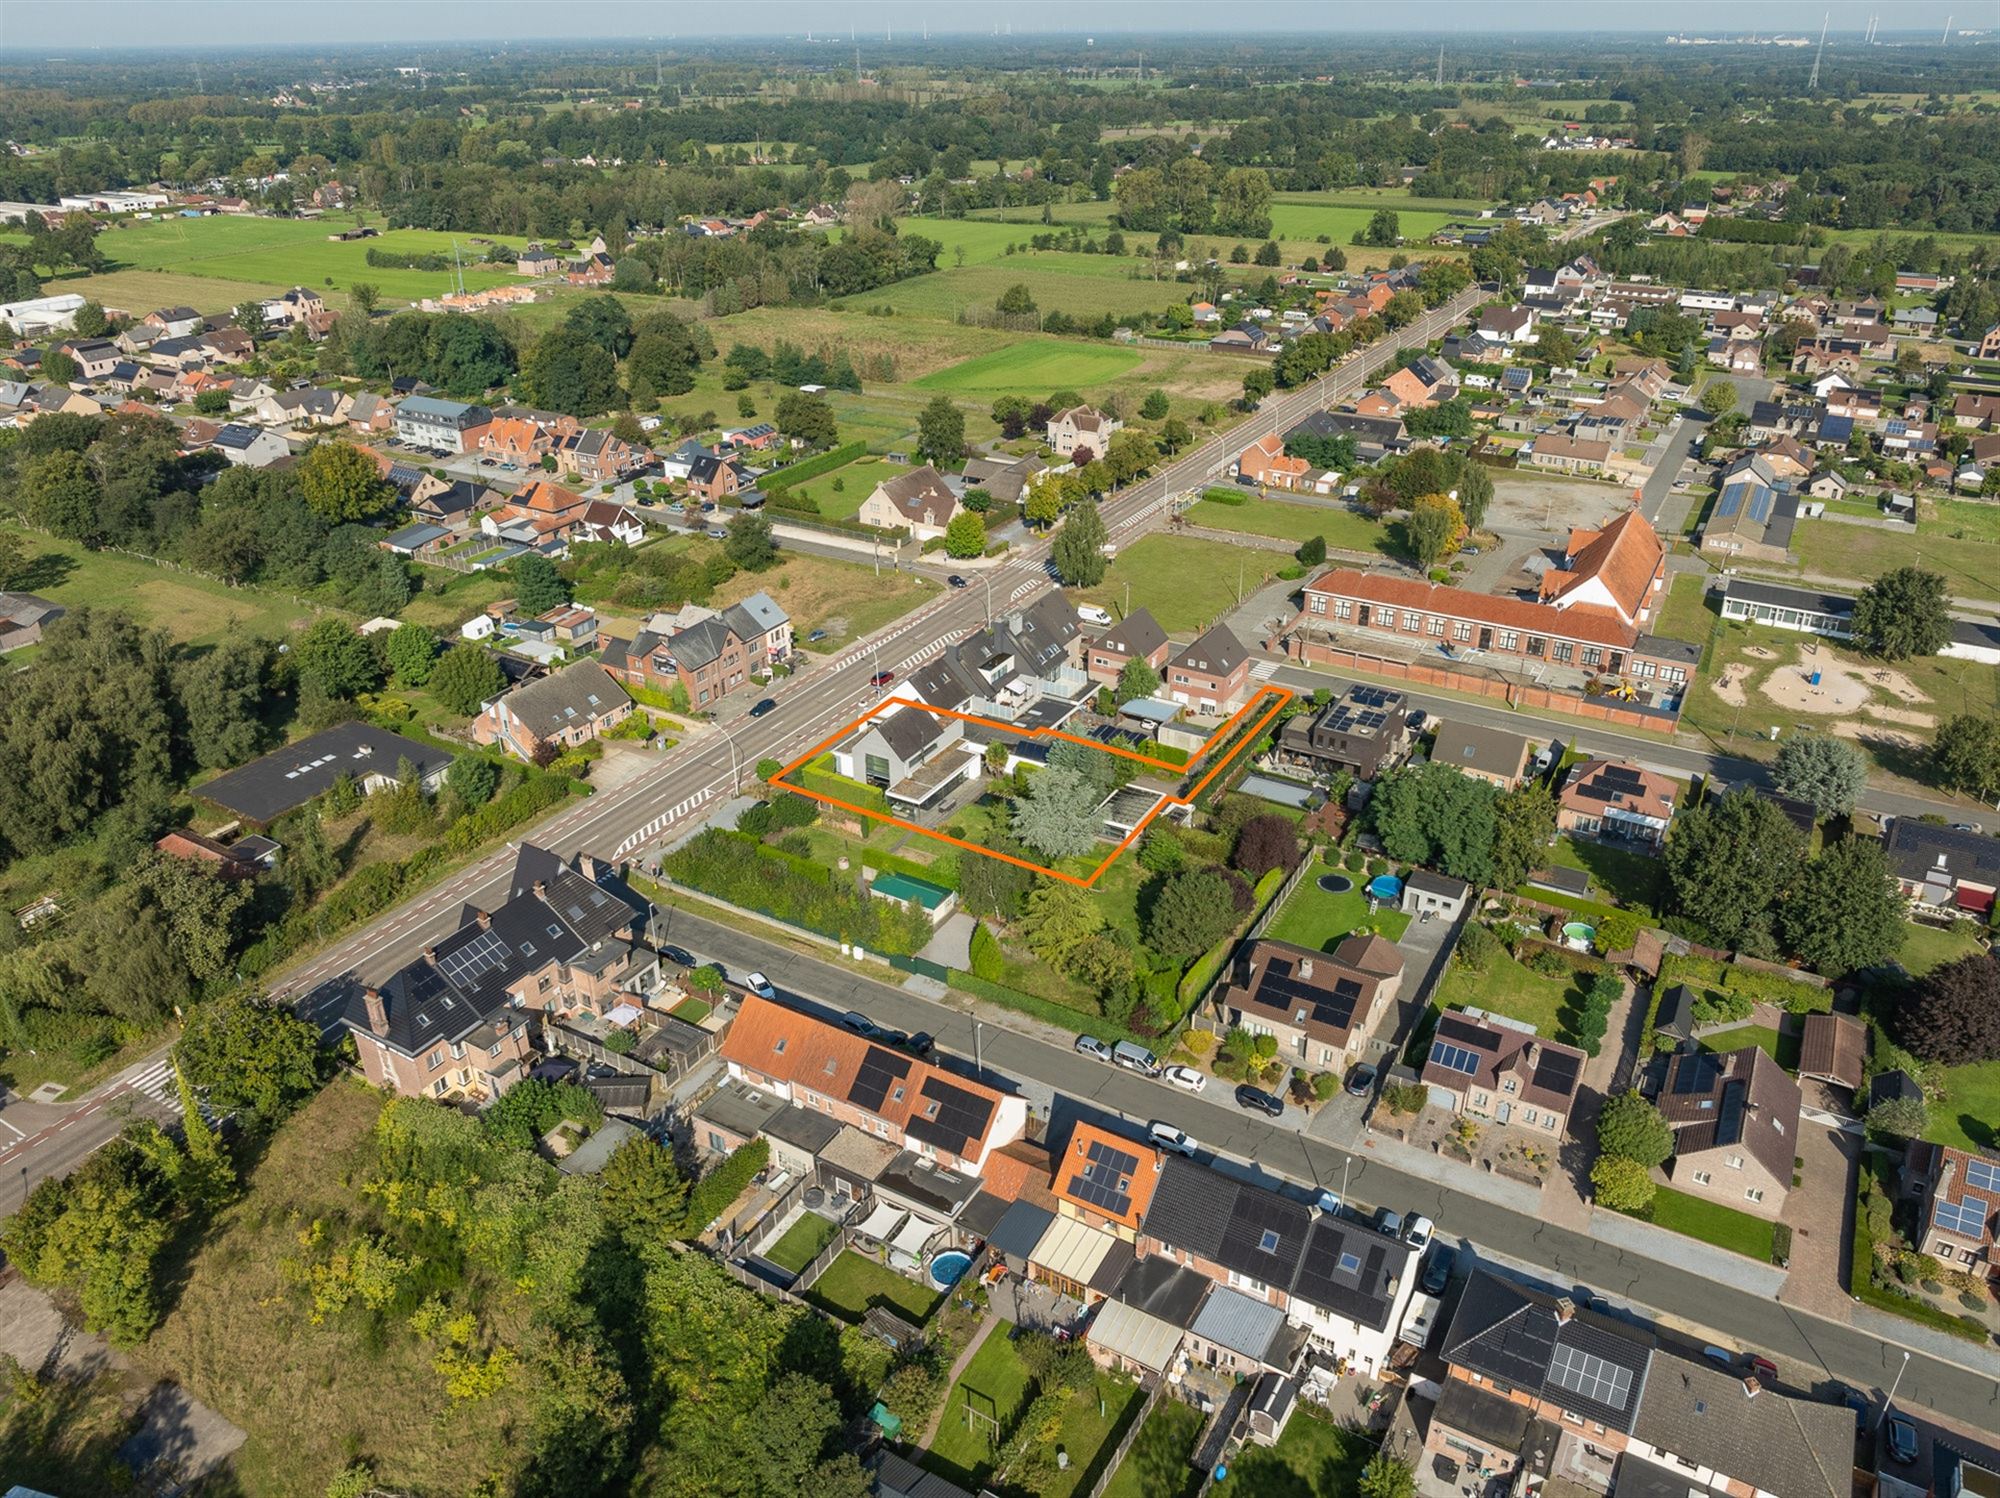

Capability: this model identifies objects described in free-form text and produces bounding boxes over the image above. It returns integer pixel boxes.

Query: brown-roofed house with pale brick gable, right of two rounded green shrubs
[1658,1046,1800,1218]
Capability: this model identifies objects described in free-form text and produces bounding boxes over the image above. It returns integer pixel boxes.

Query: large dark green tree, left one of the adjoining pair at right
[1662,790,1804,956]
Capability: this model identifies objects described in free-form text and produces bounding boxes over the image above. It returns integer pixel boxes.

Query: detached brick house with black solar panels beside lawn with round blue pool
[1220,936,1402,1072]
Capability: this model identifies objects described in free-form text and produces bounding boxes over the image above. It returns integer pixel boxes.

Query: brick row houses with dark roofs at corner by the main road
[338,844,658,1100]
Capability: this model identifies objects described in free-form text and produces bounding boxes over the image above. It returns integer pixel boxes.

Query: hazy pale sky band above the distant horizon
[0,0,1982,56]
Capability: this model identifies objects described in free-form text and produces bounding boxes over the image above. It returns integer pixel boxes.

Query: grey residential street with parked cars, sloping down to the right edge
[648,910,2000,1430]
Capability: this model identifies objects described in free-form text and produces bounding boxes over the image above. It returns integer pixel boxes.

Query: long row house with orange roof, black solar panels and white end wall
[722,994,1028,1176]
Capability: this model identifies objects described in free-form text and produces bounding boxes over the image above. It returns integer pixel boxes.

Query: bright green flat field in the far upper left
[61,214,524,304]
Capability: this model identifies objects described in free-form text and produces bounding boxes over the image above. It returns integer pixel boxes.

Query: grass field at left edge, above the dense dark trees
[1,530,334,644]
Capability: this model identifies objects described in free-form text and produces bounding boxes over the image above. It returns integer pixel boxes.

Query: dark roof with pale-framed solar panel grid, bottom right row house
[1444,1268,1654,1432]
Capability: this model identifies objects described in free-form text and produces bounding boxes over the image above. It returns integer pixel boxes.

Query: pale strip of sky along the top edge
[0,0,1968,56]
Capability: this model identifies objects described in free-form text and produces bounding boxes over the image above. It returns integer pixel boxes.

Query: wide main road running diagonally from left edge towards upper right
[0,286,1484,1212]
